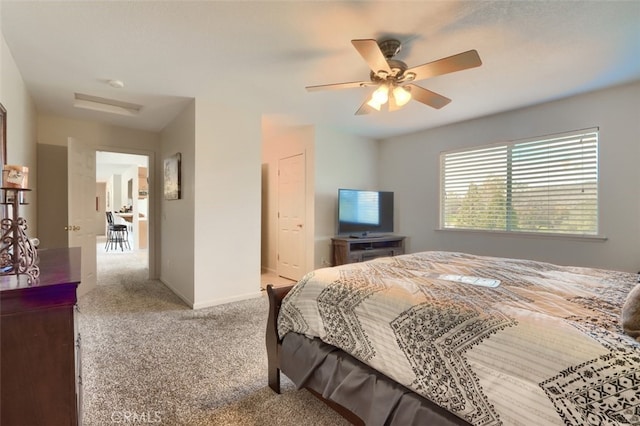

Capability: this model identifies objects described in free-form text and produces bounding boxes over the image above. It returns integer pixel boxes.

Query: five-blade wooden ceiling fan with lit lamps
[306,39,482,115]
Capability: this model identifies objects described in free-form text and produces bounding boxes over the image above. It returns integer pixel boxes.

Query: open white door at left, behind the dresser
[67,138,96,295]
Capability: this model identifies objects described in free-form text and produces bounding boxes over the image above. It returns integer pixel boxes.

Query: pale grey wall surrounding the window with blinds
[379,83,640,272]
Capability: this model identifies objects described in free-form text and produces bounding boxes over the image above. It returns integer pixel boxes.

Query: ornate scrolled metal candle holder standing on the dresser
[0,187,40,284]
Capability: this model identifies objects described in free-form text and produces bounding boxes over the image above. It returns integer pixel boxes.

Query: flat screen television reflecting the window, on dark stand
[338,189,393,238]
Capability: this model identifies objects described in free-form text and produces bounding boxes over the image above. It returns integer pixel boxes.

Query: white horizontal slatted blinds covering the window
[439,127,603,238]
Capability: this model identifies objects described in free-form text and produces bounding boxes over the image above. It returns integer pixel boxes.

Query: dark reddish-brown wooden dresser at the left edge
[0,248,82,426]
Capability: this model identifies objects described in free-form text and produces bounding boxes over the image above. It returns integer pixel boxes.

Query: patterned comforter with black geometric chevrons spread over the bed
[278,252,640,425]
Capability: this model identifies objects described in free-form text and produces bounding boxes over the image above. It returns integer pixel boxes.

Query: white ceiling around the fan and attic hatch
[0,0,640,138]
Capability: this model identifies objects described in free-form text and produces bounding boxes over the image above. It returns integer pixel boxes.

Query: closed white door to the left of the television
[278,153,305,280]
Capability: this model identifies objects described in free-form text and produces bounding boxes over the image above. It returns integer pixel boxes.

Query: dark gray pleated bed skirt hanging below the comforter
[280,333,469,426]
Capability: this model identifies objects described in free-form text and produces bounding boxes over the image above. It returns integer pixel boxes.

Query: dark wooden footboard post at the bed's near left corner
[265,284,293,393]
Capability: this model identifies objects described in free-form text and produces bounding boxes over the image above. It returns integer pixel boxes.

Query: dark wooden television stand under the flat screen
[331,235,405,266]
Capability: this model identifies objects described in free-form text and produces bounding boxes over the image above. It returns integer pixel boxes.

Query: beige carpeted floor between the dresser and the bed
[78,241,347,426]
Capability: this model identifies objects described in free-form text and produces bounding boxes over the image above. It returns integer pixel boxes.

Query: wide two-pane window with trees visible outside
[440,129,598,236]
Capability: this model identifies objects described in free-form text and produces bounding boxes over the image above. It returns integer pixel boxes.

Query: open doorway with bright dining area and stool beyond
[96,151,152,285]
